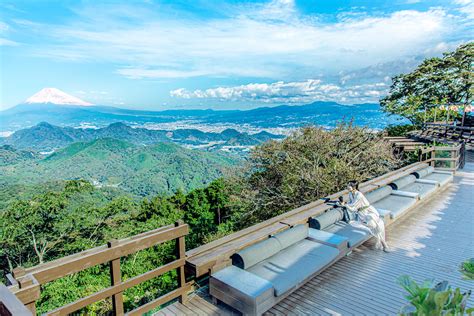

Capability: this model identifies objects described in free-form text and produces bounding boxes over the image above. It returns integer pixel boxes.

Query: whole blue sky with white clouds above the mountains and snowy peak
[0,0,474,110]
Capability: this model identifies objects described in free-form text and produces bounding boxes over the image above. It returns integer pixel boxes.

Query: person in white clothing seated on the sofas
[343,181,391,252]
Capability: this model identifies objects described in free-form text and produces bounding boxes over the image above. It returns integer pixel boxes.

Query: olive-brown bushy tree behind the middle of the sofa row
[233,123,399,224]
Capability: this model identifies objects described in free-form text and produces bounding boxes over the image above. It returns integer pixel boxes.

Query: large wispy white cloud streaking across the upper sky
[17,0,456,80]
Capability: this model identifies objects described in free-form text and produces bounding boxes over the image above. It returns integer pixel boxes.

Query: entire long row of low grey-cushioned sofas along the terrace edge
[209,167,453,315]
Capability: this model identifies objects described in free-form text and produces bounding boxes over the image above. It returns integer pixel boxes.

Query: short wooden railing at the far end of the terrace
[419,143,465,171]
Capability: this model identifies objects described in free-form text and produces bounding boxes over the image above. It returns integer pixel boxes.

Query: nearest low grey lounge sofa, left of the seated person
[209,224,348,315]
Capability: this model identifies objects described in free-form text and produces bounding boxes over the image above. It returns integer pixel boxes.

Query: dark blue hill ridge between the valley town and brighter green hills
[0,122,283,152]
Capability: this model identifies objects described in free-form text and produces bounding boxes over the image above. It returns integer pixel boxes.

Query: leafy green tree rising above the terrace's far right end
[380,42,474,124]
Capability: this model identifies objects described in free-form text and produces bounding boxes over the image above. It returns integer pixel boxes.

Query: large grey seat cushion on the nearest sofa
[247,239,339,296]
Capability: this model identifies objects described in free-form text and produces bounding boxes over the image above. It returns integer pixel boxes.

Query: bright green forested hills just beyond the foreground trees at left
[0,138,240,196]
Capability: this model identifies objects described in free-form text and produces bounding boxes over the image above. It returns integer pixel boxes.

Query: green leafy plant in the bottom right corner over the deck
[398,275,474,316]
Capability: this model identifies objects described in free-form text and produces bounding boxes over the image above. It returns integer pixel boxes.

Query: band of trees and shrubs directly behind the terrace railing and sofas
[0,124,400,314]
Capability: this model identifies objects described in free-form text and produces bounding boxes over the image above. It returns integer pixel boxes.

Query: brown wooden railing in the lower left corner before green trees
[0,221,190,315]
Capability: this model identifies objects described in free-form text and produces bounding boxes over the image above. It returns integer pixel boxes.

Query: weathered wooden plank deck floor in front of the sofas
[156,157,474,316]
